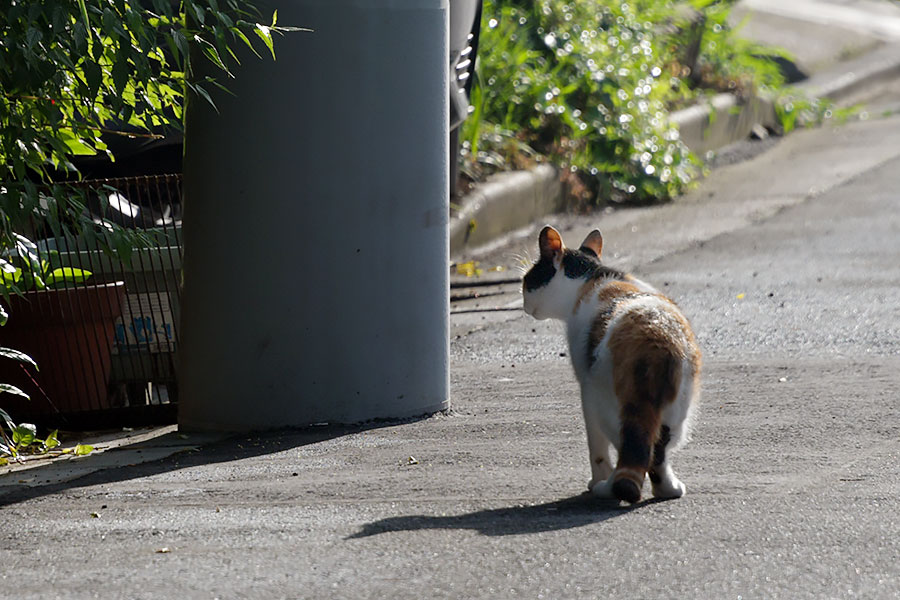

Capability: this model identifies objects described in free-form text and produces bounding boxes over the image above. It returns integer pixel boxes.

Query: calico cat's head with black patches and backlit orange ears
[522,225,604,319]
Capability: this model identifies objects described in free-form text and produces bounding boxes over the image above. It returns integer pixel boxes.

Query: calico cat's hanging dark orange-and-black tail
[612,347,681,504]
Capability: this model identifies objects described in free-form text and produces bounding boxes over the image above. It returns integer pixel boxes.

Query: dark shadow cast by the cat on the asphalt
[347,492,655,539]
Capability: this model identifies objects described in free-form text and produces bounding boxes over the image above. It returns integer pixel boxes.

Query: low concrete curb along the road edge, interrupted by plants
[450,43,900,256]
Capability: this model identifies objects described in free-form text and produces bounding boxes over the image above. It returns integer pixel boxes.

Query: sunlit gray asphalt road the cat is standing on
[0,117,900,599]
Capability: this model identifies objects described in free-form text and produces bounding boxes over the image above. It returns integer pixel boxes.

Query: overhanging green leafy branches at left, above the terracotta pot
[0,0,295,249]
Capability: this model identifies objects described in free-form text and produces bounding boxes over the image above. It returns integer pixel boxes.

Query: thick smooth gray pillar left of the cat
[179,0,449,430]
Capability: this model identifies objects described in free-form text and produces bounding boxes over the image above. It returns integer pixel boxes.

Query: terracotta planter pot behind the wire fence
[0,281,125,422]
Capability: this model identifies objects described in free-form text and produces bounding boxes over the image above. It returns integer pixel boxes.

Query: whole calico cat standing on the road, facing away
[522,226,701,503]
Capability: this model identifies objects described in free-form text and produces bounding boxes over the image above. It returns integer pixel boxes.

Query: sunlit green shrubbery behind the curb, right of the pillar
[462,0,796,202]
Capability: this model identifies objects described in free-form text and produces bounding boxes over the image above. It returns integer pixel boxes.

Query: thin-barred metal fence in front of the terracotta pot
[0,175,183,429]
